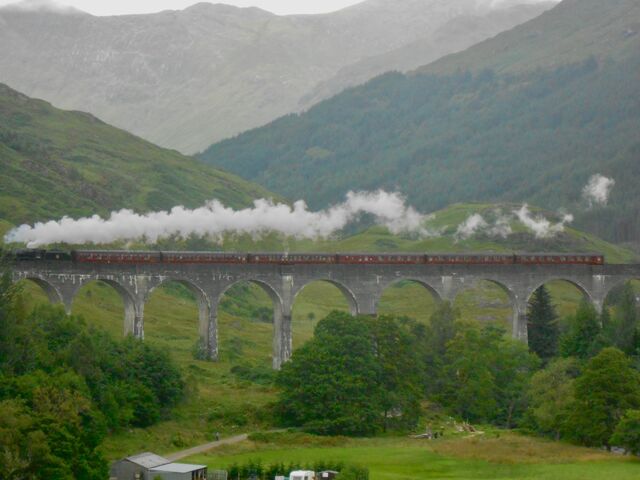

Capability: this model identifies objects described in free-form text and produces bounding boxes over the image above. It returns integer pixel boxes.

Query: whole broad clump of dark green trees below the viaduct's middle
[277,312,423,435]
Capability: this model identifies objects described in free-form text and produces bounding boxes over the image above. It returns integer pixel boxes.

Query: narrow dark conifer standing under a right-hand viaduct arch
[527,285,560,361]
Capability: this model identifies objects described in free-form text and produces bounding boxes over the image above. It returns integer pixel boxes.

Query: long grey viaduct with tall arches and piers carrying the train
[13,261,640,368]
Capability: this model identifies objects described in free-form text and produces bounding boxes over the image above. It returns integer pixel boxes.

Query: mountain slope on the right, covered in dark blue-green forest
[202,0,640,241]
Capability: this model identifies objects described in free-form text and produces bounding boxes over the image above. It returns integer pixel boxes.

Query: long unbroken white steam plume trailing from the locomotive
[5,190,436,248]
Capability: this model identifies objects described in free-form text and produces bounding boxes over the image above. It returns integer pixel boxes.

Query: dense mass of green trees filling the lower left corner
[0,275,184,480]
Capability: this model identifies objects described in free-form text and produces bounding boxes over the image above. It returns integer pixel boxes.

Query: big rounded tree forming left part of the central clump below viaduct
[276,312,384,435]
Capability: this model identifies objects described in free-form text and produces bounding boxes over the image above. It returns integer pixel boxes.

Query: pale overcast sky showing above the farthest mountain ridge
[0,0,362,15]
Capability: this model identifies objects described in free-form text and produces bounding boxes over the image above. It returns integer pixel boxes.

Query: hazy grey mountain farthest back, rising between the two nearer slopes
[0,0,551,153]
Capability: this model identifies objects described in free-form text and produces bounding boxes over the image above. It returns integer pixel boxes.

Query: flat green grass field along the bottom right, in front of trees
[185,431,640,480]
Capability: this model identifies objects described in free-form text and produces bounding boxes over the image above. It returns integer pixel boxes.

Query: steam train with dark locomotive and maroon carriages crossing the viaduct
[13,249,605,265]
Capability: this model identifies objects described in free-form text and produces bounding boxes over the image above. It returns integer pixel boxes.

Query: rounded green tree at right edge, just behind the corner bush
[564,347,640,447]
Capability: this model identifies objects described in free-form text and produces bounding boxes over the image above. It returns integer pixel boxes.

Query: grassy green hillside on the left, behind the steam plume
[0,84,272,224]
